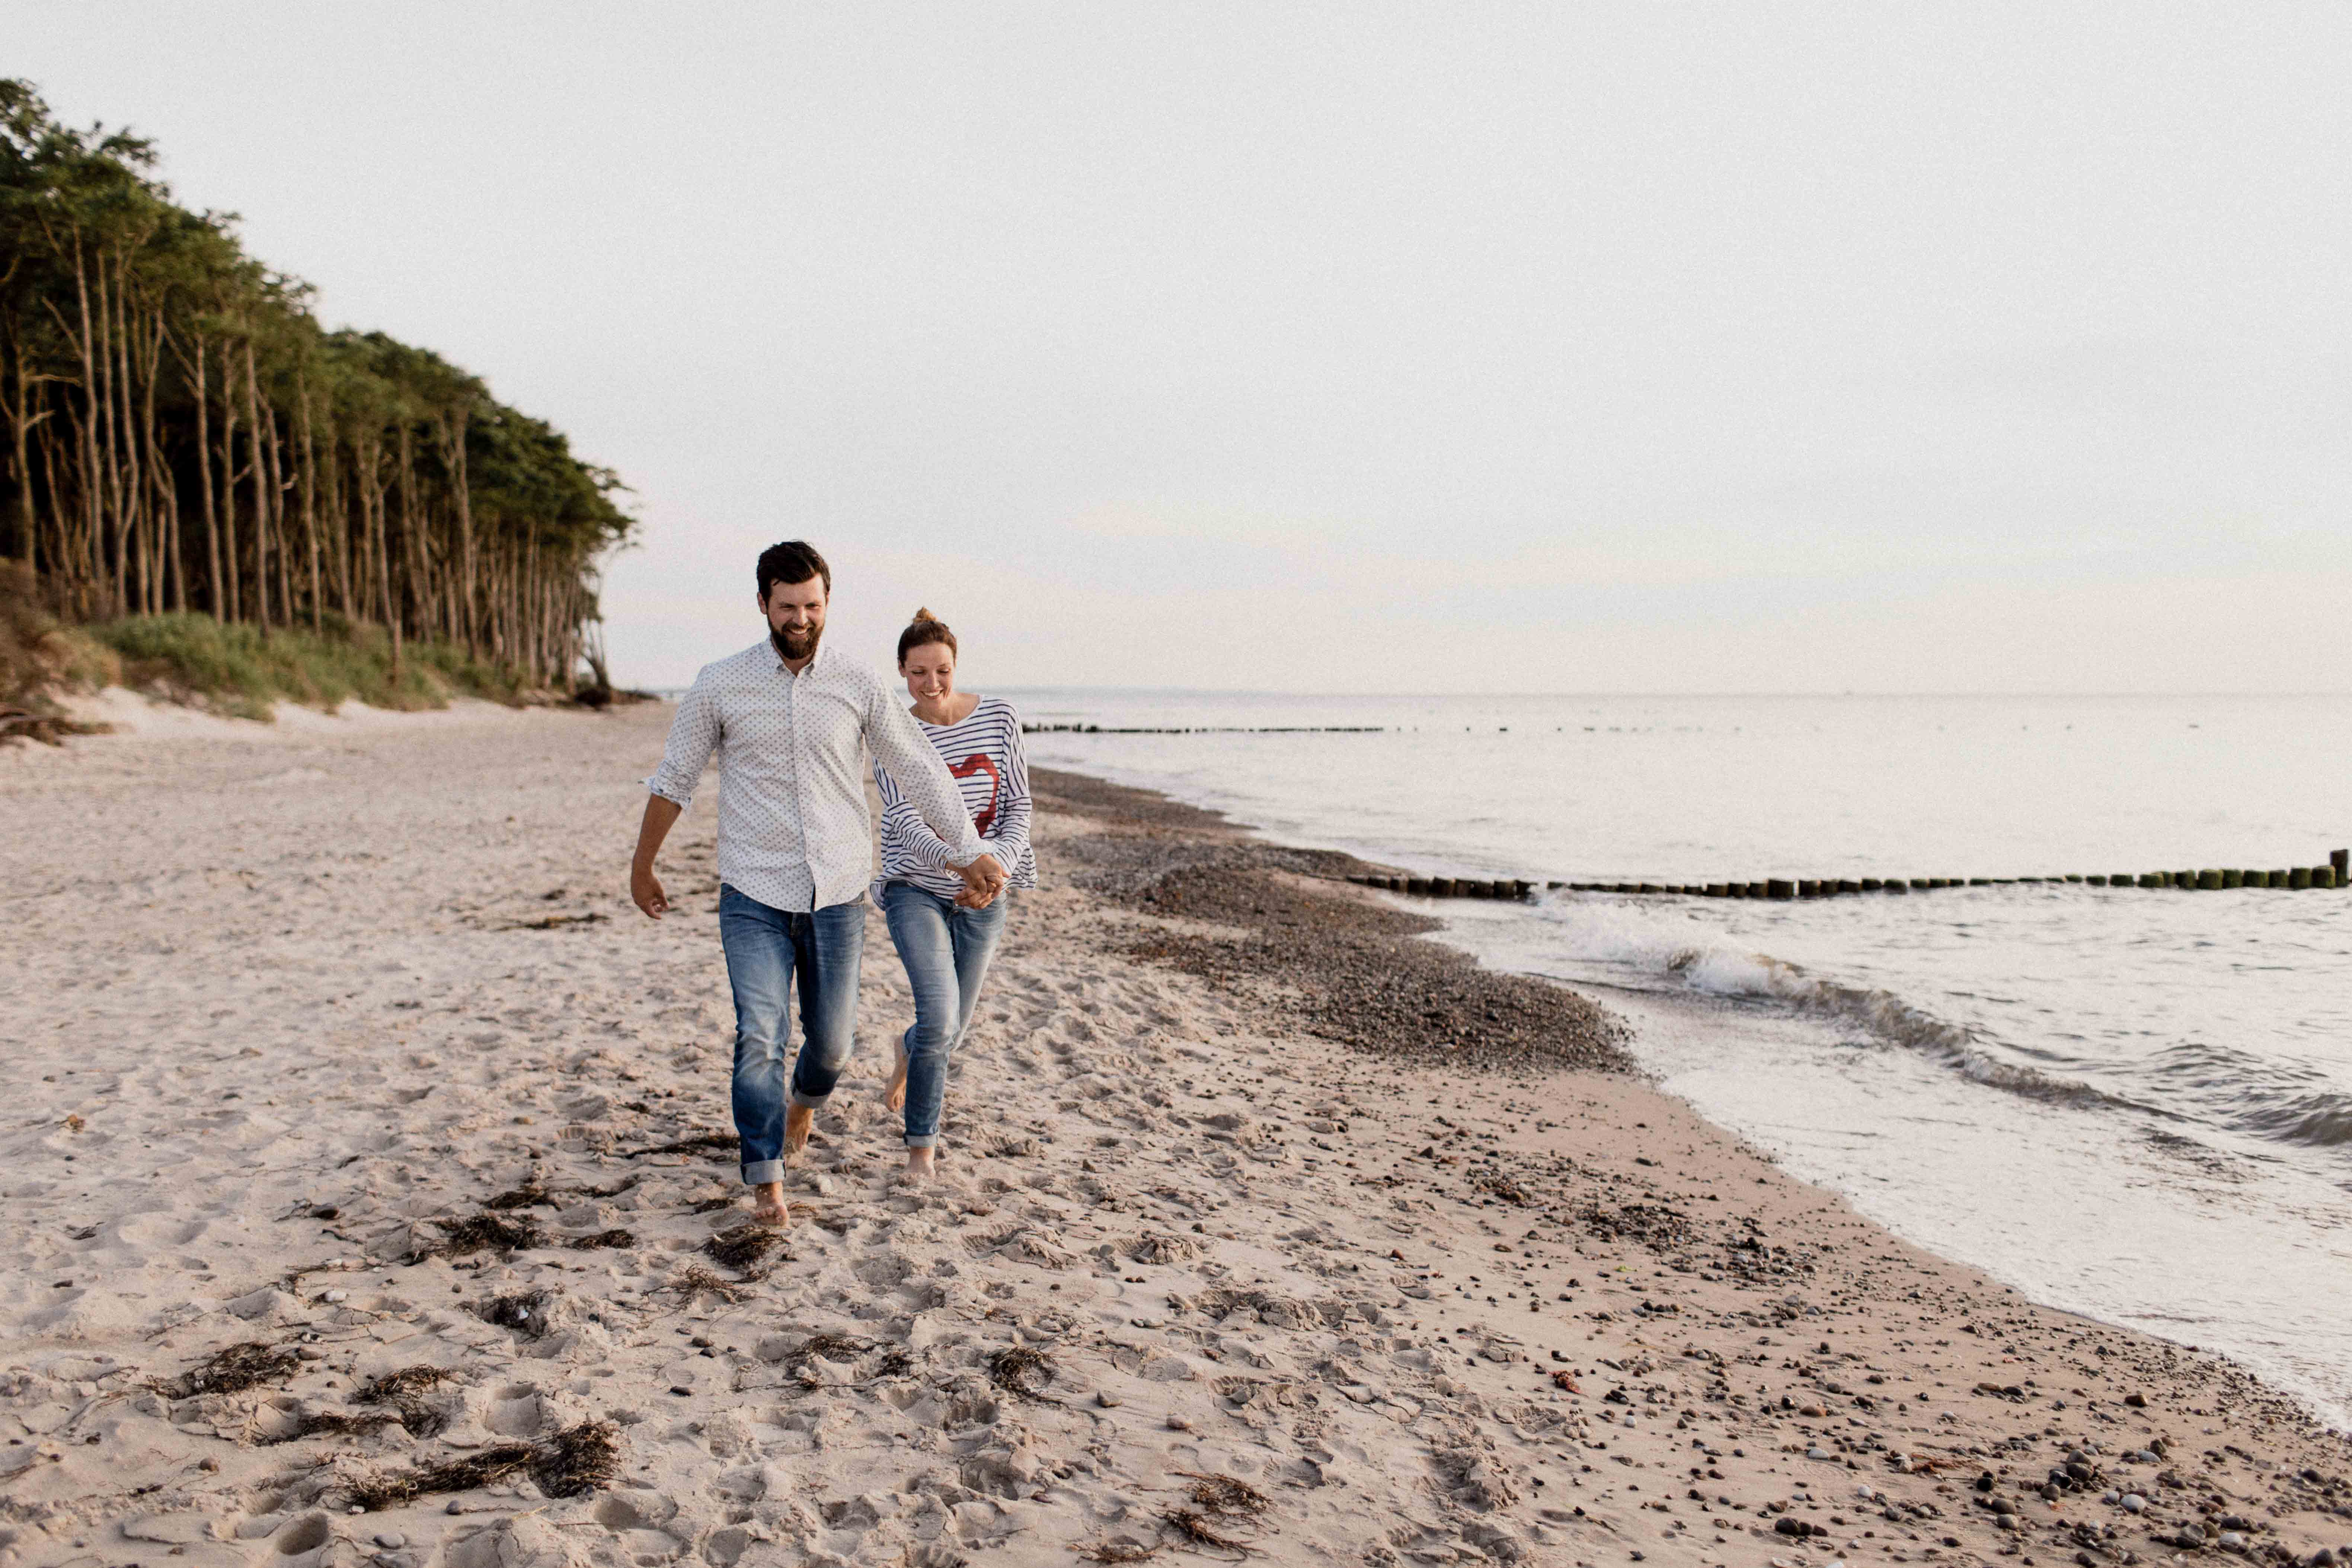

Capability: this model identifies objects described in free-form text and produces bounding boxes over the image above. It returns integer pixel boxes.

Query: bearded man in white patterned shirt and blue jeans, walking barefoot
[628,538,1007,1225]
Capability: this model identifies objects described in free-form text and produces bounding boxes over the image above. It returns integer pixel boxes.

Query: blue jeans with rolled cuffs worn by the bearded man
[720,886,866,1182]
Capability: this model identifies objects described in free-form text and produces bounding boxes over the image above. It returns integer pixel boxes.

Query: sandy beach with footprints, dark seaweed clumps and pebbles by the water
[0,703,2352,1568]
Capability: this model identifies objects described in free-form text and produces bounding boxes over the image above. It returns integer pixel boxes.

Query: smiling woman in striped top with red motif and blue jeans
[875,609,1037,1180]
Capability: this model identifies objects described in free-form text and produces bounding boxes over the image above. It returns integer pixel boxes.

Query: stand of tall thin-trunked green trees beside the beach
[0,77,633,684]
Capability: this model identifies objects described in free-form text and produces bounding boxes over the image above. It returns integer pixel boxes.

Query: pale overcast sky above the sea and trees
[18,0,2352,691]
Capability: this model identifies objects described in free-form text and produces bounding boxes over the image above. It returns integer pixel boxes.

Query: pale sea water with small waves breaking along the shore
[1007,691,2352,1427]
